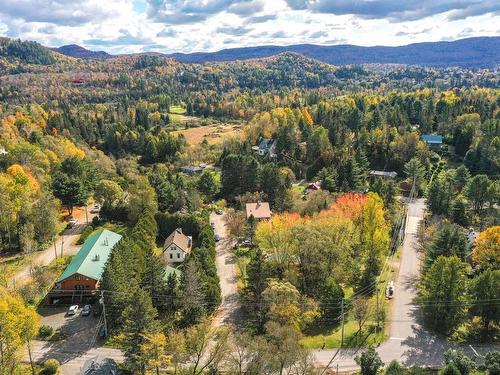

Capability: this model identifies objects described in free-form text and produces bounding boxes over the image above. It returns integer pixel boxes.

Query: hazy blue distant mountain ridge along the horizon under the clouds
[55,36,500,68]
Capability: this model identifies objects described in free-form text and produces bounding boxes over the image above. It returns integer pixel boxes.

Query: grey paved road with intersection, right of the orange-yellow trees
[314,199,498,371]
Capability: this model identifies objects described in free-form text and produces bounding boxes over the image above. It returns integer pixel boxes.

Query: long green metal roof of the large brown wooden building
[57,229,122,282]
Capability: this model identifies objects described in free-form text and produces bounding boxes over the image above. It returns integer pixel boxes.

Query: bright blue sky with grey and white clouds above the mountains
[0,0,500,54]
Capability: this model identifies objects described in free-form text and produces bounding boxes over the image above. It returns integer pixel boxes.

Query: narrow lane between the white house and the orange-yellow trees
[210,213,240,327]
